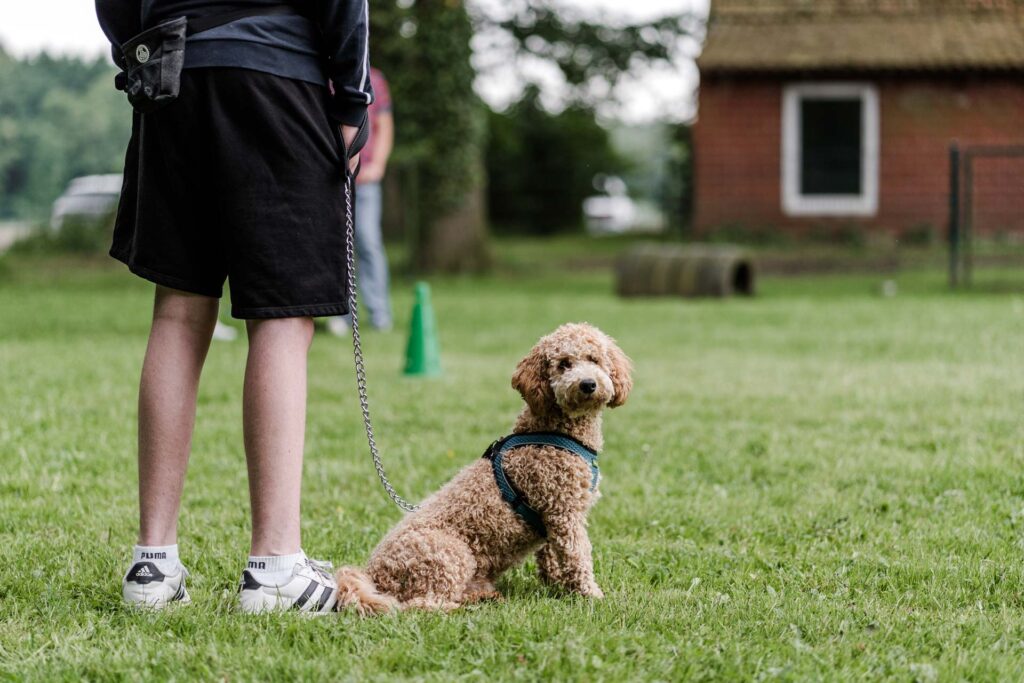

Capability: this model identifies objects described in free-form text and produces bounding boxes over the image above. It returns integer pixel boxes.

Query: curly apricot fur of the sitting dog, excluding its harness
[337,324,633,614]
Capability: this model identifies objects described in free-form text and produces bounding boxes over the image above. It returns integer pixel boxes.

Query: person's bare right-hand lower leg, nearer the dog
[243,317,313,555]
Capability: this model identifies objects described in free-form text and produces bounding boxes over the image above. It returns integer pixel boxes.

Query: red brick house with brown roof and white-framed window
[693,0,1024,240]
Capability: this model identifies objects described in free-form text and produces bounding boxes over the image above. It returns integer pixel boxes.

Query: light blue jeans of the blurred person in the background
[344,182,391,330]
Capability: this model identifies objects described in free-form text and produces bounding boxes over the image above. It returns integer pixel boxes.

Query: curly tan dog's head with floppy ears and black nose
[512,323,633,418]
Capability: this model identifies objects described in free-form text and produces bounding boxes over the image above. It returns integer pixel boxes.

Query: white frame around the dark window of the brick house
[781,82,879,216]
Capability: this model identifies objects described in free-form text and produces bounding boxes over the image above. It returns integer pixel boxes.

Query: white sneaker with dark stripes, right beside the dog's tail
[239,558,338,614]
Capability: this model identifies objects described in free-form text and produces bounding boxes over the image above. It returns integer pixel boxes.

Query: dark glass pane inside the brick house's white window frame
[800,97,862,195]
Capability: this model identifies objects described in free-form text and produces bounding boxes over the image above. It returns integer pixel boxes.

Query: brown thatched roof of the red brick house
[697,0,1024,74]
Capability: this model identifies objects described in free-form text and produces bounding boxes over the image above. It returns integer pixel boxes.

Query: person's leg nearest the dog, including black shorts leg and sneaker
[211,69,339,613]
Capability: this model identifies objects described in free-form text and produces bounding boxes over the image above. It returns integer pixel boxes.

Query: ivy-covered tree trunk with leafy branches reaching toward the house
[371,0,698,270]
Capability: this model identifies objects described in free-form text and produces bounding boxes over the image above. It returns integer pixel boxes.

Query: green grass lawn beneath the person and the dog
[0,249,1024,681]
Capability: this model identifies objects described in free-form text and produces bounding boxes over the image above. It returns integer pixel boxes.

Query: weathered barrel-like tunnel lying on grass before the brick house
[616,244,755,297]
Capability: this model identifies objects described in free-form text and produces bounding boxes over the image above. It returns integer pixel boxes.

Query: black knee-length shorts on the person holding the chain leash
[111,68,348,318]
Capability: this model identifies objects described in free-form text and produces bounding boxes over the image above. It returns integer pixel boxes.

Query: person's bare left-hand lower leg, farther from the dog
[138,286,218,546]
